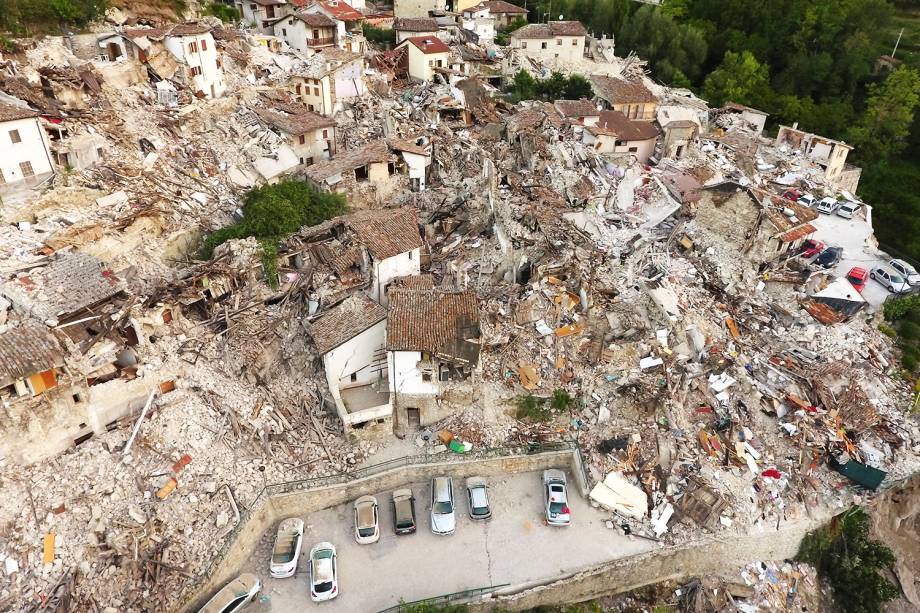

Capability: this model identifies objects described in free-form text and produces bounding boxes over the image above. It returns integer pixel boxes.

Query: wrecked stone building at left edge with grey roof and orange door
[0,253,172,463]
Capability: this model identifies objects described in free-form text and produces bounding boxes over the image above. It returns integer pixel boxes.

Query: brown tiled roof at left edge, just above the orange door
[0,320,62,385]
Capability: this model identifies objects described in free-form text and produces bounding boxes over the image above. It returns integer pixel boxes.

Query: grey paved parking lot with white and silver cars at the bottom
[237,472,655,613]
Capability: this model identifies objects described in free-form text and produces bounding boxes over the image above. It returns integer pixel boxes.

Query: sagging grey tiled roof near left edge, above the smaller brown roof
[0,252,122,321]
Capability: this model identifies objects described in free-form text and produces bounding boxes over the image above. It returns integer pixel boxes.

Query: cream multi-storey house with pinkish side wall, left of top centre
[288,47,367,117]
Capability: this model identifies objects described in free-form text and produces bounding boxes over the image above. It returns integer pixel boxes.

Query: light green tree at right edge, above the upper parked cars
[849,66,920,162]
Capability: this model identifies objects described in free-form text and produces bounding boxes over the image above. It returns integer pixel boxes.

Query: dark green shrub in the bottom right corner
[796,507,900,613]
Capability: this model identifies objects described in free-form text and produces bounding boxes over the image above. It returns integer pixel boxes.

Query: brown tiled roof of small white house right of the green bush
[346,208,423,261]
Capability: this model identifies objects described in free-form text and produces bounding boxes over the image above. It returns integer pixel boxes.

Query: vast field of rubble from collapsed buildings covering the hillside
[0,5,920,612]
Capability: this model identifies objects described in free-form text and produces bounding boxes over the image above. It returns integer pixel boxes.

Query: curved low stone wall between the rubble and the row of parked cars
[178,449,583,611]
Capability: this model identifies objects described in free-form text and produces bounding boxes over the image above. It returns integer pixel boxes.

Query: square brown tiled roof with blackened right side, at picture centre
[387,289,480,364]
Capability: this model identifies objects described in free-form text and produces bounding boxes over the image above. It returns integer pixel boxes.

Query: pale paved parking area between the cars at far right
[812,208,890,306]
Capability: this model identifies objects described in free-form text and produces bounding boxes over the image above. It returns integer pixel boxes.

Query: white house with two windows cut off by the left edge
[0,101,54,194]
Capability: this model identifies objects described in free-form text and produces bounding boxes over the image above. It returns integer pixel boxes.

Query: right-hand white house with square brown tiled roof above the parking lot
[387,288,480,436]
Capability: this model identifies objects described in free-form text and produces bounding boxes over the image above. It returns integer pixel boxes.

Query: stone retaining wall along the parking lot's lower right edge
[470,512,832,613]
